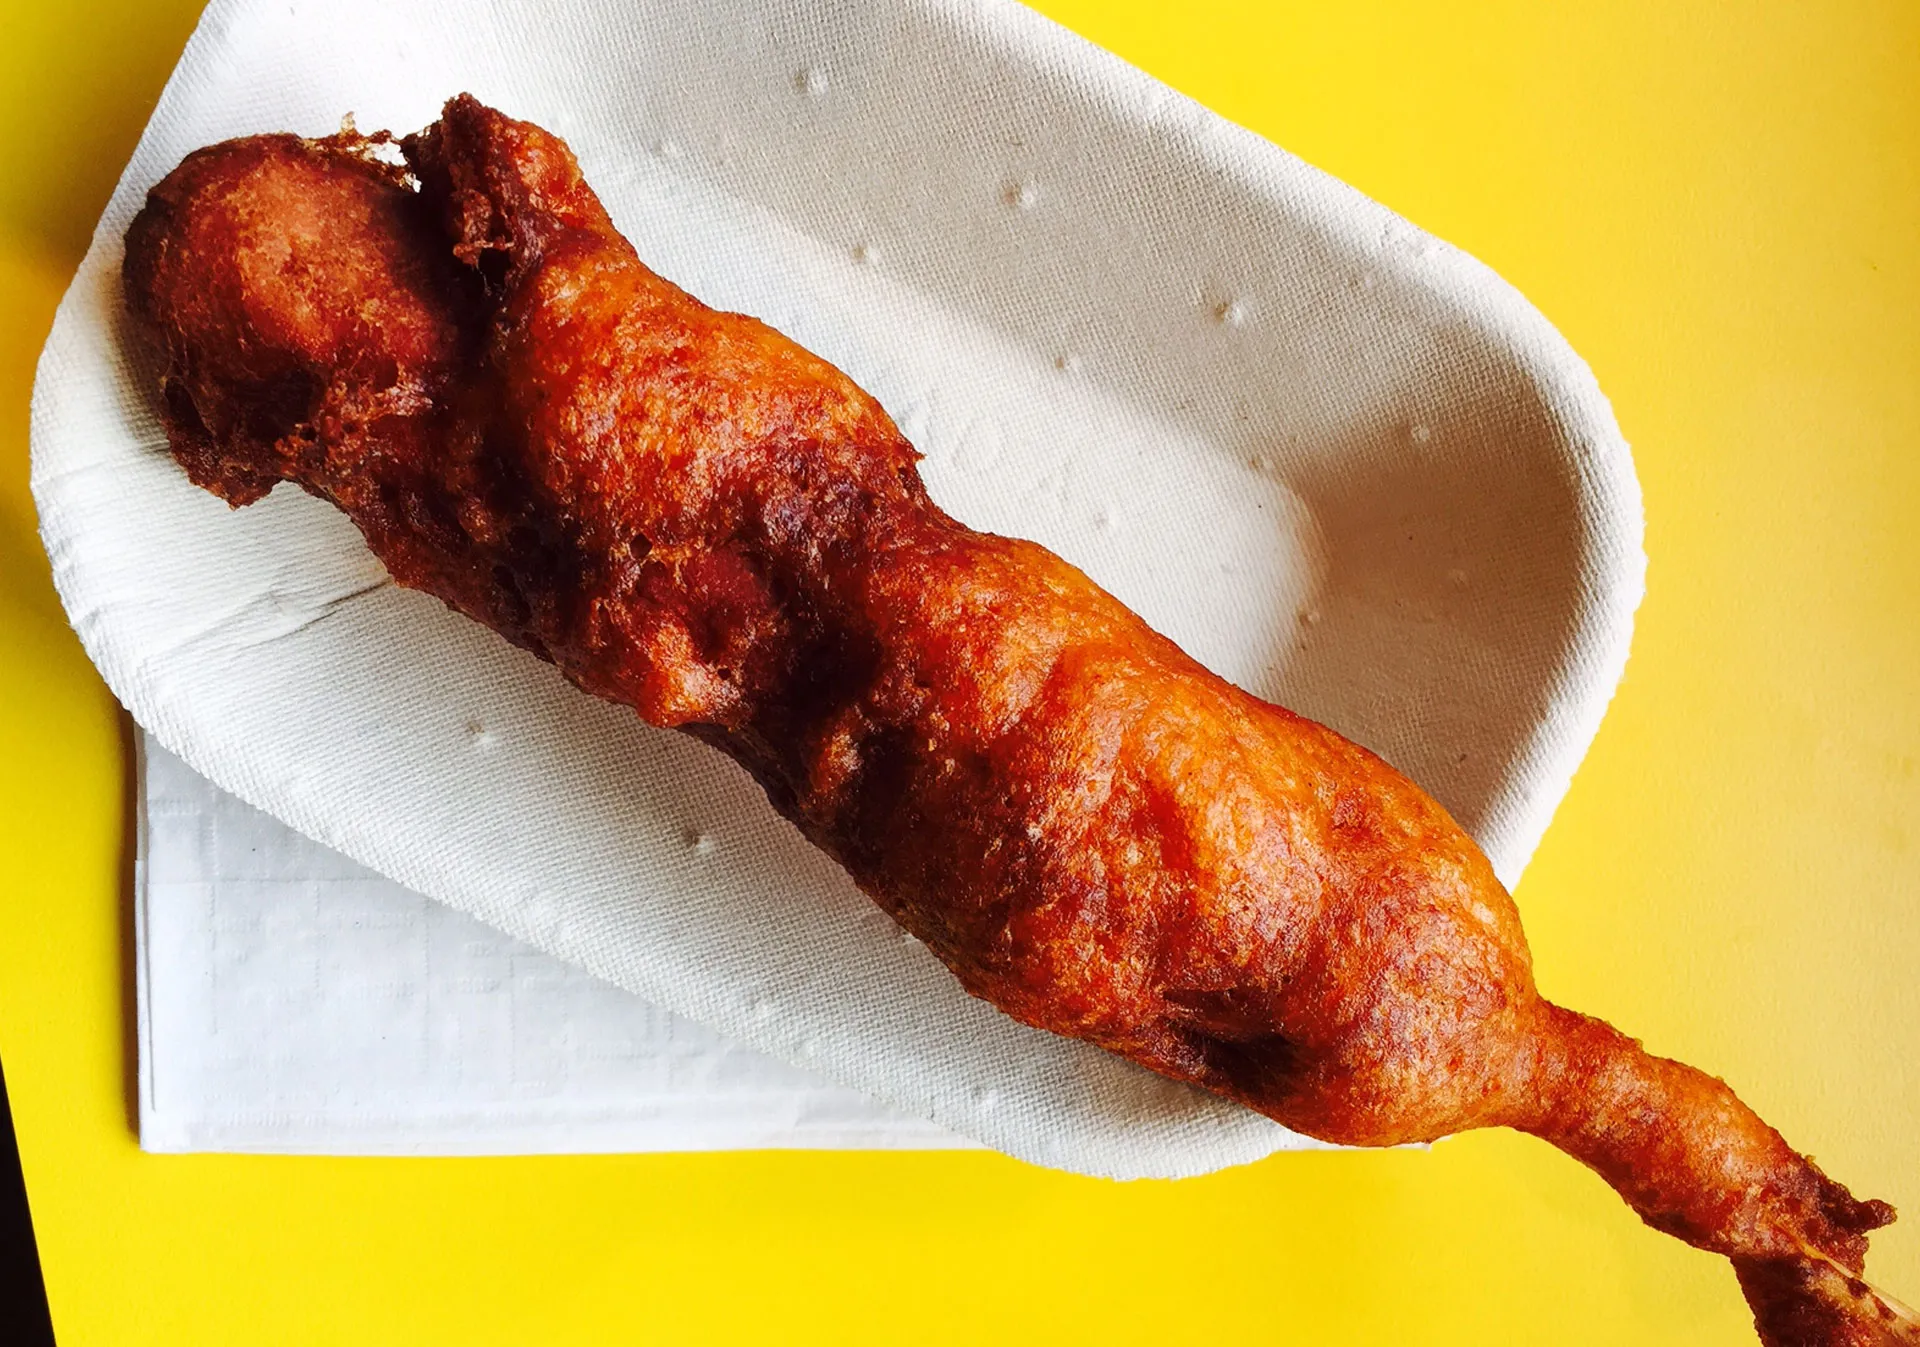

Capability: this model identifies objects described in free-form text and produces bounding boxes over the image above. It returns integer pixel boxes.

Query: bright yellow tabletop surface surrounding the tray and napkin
[0,0,1920,1347]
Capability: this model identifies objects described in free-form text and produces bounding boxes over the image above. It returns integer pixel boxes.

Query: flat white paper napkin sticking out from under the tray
[134,737,972,1155]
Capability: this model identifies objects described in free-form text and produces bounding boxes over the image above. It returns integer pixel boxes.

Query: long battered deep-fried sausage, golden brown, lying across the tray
[125,98,1920,1345]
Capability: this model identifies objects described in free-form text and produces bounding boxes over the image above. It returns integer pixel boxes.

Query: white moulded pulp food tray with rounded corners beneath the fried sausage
[33,0,1644,1174]
